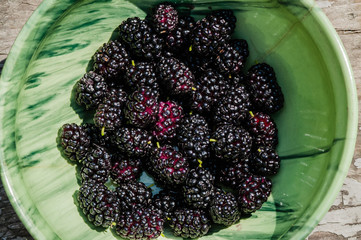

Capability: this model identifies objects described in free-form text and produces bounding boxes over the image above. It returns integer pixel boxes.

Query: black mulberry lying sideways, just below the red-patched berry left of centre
[112,127,153,158]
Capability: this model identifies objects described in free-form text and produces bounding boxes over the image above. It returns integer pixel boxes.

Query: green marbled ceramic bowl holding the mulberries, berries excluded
[0,0,357,240]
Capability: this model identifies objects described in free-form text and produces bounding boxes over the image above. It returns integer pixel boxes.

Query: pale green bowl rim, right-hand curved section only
[291,0,358,239]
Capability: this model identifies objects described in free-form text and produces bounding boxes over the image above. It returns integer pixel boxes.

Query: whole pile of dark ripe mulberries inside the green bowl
[57,2,286,240]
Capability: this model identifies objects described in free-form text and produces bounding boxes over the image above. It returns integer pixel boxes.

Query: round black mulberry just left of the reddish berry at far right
[211,125,252,162]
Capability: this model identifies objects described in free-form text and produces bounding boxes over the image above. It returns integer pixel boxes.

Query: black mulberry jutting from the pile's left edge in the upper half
[75,71,107,110]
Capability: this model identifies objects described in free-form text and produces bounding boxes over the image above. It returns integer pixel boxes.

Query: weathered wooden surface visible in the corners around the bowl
[0,0,361,240]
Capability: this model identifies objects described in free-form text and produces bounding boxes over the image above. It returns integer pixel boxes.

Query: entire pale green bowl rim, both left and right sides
[0,0,358,239]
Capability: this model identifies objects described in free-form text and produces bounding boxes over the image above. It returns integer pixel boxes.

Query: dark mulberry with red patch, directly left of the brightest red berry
[124,86,159,128]
